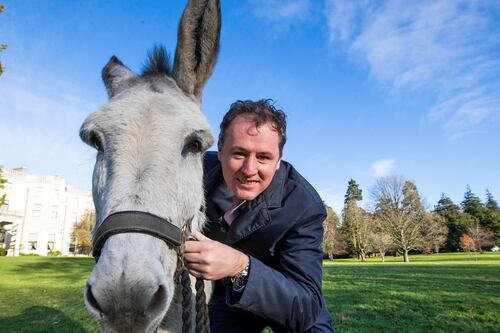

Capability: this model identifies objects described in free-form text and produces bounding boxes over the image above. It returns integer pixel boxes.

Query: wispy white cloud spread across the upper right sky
[326,0,500,136]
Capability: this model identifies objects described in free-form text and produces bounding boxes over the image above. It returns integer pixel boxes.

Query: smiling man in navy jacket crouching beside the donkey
[185,100,333,333]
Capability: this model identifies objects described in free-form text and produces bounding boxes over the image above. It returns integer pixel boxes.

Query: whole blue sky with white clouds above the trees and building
[0,0,500,212]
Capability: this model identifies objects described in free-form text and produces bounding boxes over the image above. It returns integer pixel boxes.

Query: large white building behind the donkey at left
[0,167,94,255]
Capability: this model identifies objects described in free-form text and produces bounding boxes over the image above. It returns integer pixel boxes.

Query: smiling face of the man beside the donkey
[218,115,280,200]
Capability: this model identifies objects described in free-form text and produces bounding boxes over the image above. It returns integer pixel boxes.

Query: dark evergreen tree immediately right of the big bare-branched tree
[434,193,473,251]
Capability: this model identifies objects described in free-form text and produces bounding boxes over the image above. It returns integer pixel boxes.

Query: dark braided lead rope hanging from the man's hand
[174,221,210,333]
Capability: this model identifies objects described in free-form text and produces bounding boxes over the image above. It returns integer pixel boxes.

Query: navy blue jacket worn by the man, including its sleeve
[204,152,333,333]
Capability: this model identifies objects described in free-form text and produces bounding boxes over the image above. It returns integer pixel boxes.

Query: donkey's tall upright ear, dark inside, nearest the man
[172,0,221,100]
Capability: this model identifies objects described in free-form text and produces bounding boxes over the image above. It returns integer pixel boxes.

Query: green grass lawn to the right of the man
[323,253,500,332]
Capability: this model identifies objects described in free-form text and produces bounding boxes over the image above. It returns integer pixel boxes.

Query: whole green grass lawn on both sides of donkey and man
[0,253,500,333]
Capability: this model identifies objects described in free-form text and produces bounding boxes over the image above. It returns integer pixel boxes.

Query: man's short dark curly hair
[218,99,286,156]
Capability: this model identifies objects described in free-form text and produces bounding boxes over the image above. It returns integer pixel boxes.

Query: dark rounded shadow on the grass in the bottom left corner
[0,306,86,333]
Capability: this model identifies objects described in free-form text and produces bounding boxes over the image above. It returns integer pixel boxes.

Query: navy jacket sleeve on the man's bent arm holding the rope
[226,203,326,332]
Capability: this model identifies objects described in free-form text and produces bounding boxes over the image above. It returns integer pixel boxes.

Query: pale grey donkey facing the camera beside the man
[80,0,221,333]
